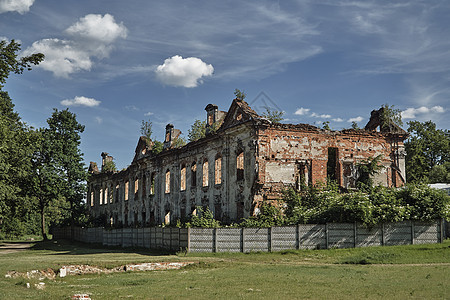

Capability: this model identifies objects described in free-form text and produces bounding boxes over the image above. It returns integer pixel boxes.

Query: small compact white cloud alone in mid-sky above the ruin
[155,55,214,88]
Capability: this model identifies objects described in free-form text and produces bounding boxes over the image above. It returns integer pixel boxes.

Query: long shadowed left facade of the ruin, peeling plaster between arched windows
[88,124,257,225]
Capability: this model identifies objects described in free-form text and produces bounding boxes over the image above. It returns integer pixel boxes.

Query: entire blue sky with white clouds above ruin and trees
[0,0,450,168]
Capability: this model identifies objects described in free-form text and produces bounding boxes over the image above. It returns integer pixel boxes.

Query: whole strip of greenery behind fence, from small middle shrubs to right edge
[178,182,450,228]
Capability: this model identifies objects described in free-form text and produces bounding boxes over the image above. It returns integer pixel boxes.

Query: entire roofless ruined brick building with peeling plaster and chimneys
[87,99,407,226]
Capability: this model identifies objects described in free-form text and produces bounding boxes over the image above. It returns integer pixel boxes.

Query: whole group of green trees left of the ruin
[0,40,87,239]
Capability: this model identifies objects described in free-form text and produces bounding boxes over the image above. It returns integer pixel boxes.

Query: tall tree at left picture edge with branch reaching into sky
[0,40,44,234]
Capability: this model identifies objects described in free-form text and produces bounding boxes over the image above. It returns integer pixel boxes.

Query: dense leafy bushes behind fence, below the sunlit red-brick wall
[283,184,450,226]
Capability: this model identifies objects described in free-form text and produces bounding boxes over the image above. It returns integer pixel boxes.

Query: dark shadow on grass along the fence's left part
[30,240,175,256]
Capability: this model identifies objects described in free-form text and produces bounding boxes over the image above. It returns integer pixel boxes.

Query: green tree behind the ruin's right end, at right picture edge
[405,121,450,182]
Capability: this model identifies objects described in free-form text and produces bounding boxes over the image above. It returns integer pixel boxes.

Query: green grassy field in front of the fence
[0,240,450,299]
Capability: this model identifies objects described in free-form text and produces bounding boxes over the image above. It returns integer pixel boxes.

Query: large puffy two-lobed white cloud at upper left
[22,14,127,78]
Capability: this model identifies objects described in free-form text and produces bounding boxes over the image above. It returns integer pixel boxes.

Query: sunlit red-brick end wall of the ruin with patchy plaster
[257,124,404,200]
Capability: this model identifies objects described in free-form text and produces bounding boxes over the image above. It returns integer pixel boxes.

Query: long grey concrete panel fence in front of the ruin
[53,221,445,252]
